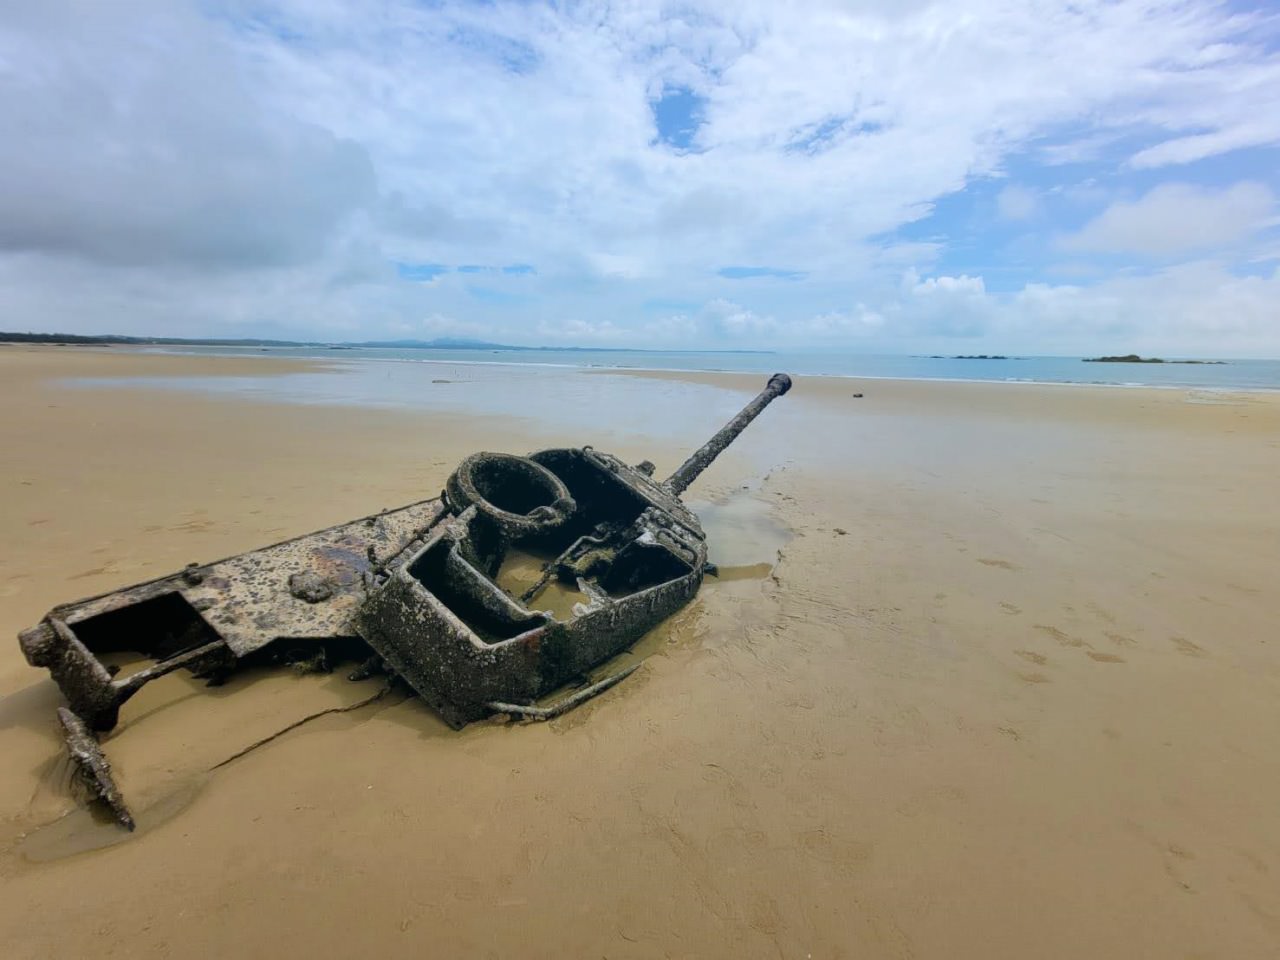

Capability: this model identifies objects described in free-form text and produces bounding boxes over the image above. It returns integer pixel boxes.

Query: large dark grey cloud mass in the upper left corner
[0,0,375,269]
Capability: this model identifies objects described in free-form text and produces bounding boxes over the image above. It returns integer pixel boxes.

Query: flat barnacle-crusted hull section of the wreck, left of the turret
[18,499,444,730]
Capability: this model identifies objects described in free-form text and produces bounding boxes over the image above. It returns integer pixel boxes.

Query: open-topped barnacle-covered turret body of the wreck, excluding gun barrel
[357,449,707,727]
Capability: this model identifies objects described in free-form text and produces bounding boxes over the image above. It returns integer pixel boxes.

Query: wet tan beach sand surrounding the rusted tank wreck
[0,348,1280,957]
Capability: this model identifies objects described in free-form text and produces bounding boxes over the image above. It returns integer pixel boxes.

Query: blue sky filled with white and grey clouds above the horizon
[0,0,1280,357]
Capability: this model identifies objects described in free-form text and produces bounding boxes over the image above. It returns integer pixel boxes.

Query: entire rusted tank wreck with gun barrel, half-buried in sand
[18,374,791,829]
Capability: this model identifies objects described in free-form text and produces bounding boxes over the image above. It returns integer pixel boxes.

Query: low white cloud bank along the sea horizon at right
[634,261,1280,357]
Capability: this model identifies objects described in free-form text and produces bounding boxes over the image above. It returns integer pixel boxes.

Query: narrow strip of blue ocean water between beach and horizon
[147,347,1280,390]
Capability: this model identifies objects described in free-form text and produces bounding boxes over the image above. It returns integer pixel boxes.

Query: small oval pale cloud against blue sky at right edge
[1059,182,1275,256]
